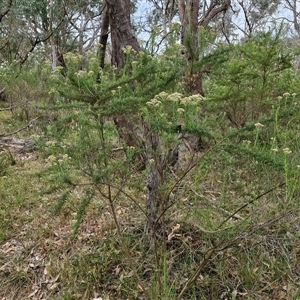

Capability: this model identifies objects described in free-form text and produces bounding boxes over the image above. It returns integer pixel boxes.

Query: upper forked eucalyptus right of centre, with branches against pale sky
[140,0,231,94]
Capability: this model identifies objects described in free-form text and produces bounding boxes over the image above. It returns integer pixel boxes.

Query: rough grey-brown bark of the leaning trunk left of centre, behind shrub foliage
[103,0,169,241]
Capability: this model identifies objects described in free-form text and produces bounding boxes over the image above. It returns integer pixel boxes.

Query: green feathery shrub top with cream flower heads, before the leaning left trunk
[52,48,184,112]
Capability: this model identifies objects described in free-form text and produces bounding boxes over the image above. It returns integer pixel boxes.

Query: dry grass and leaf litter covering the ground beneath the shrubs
[0,110,300,300]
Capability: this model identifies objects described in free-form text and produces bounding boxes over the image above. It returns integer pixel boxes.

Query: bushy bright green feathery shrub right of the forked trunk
[207,26,293,127]
